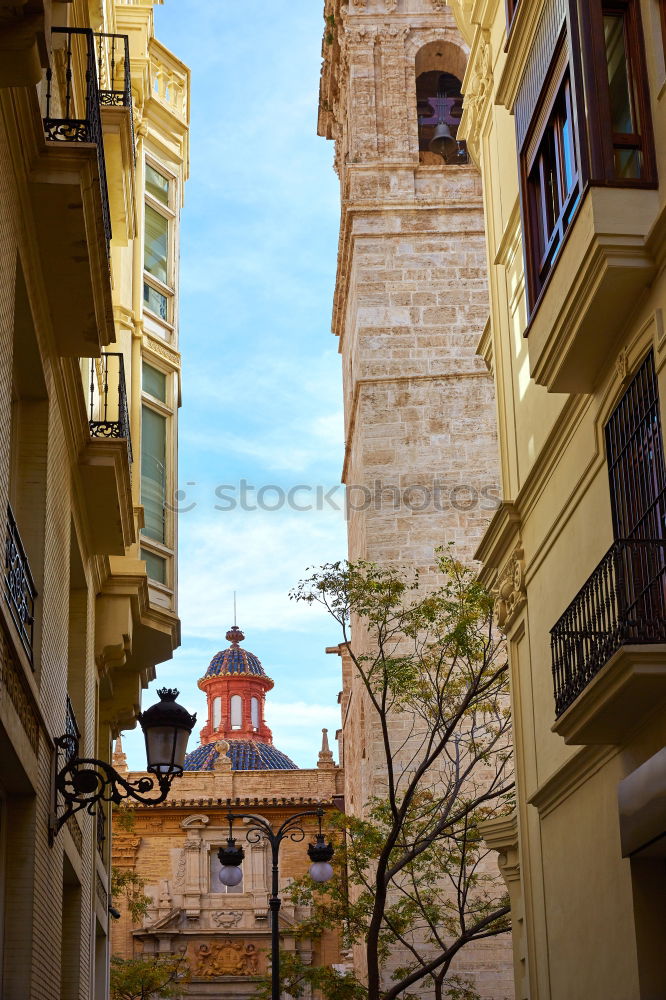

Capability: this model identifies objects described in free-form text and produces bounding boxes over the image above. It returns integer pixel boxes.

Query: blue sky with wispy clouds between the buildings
[124,0,346,769]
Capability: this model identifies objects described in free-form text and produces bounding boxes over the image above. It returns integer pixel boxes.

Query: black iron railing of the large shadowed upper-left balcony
[44,28,111,253]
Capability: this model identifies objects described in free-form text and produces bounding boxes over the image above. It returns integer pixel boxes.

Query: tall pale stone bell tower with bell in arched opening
[318,0,513,1000]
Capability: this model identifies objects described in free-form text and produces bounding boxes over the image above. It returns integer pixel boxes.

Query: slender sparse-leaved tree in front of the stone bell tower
[284,552,513,1000]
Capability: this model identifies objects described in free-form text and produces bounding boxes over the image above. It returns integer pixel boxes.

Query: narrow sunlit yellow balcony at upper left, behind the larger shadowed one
[94,32,136,246]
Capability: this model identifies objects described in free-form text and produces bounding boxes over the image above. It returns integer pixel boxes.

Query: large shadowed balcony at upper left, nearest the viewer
[29,28,115,357]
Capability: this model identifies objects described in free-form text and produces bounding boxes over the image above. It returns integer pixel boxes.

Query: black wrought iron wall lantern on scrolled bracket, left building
[50,688,197,843]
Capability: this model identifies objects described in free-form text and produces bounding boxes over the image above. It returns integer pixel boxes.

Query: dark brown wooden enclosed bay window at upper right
[514,0,656,313]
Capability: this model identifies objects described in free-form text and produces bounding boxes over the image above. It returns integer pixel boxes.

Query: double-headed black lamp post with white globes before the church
[217,806,333,1000]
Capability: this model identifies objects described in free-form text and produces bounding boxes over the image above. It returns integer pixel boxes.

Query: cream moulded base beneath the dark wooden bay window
[526,187,659,392]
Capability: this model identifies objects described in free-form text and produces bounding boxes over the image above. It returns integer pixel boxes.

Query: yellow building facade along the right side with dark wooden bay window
[450,0,666,1000]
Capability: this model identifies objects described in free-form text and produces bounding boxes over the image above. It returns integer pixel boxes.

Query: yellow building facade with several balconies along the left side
[0,0,189,1000]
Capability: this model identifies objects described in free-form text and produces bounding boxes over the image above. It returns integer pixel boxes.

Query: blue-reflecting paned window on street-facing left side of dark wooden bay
[526,71,581,299]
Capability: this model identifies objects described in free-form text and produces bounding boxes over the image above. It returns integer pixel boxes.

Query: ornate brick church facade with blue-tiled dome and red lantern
[113,626,343,1000]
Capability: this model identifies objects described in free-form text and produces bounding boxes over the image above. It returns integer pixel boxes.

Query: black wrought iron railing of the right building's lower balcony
[550,538,666,716]
